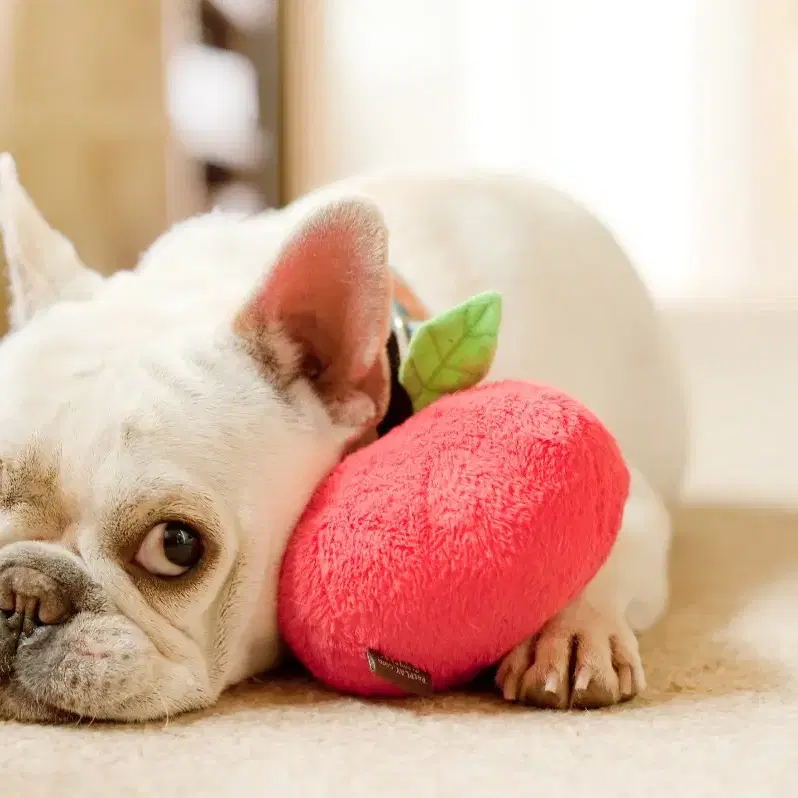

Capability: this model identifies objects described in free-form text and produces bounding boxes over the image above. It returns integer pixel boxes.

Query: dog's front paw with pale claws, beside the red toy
[496,599,645,709]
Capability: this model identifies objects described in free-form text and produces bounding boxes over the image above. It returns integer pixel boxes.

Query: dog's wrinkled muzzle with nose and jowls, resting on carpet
[0,556,215,723]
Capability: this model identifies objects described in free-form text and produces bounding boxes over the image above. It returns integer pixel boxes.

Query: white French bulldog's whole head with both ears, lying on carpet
[0,156,390,720]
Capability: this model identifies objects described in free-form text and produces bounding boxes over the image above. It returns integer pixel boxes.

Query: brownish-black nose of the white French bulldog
[0,565,75,636]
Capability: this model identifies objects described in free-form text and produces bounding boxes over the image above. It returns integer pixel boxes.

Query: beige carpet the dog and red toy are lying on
[0,508,798,798]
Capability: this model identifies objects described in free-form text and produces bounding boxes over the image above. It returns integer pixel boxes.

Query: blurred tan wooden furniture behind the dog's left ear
[0,0,203,329]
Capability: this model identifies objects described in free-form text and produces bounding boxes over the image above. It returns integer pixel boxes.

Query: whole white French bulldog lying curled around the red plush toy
[0,155,686,721]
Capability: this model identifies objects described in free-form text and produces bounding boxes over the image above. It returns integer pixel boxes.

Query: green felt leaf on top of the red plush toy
[399,291,502,412]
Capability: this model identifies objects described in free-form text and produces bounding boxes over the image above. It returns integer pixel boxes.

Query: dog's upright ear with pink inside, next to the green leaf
[235,198,391,429]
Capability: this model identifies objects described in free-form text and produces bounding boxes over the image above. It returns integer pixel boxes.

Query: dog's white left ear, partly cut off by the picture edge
[0,153,102,328]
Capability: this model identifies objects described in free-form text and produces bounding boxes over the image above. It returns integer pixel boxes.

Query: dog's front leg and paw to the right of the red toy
[496,469,671,709]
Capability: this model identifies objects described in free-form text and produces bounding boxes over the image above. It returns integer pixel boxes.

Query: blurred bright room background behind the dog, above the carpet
[0,0,798,503]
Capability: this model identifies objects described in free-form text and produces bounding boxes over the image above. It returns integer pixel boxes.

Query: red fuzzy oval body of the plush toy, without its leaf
[279,382,629,695]
